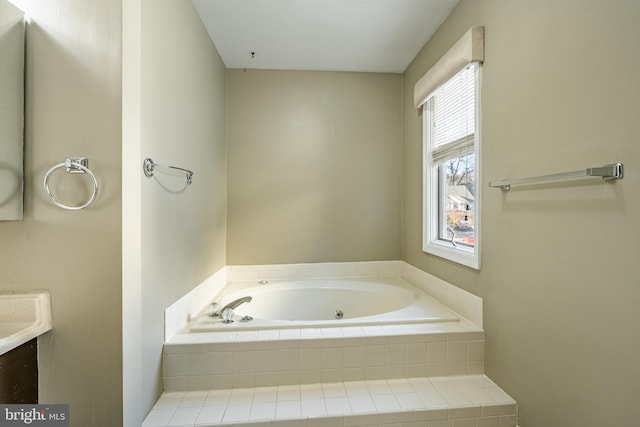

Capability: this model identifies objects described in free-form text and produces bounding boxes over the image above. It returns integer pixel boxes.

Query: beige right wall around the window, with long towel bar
[402,0,640,427]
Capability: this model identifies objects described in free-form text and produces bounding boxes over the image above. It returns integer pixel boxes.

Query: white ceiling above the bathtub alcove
[193,0,458,73]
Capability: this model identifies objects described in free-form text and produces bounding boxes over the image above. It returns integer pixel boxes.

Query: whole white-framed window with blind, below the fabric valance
[423,62,481,269]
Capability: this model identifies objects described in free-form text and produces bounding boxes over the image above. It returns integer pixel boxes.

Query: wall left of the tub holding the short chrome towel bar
[123,0,226,426]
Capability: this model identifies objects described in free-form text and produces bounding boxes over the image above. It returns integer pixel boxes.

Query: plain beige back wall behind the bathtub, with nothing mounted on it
[227,69,402,264]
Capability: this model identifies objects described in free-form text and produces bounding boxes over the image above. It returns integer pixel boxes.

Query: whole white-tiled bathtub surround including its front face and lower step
[149,261,517,427]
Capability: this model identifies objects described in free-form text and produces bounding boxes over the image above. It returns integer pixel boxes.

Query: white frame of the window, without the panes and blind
[422,62,482,270]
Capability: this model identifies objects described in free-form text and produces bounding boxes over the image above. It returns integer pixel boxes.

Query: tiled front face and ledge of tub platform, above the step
[163,320,484,391]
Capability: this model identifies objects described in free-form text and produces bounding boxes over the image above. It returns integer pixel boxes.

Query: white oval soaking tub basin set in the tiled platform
[187,278,459,332]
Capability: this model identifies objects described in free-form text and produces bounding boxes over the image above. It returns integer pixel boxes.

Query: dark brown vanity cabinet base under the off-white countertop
[0,338,38,403]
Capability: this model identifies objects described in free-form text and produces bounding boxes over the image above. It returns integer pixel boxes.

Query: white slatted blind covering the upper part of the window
[427,64,477,163]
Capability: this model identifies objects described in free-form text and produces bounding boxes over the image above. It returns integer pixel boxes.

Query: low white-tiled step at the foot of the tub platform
[142,375,517,427]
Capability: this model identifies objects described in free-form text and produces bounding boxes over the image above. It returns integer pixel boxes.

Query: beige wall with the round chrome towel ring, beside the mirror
[0,0,122,427]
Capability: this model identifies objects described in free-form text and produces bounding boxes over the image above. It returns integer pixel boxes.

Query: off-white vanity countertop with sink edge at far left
[0,291,51,355]
